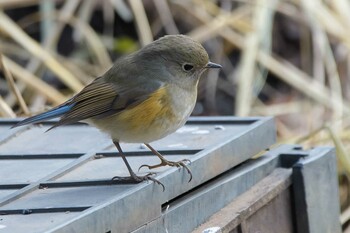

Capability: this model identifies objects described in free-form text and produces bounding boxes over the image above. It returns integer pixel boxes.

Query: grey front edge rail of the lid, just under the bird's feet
[45,118,275,232]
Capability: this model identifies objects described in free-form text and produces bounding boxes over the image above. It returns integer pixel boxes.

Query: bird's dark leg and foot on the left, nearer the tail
[112,141,165,191]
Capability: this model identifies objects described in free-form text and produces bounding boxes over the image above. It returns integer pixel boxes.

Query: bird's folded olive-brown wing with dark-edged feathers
[54,78,162,127]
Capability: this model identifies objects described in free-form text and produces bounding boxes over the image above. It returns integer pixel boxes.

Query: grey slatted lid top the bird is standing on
[0,117,275,232]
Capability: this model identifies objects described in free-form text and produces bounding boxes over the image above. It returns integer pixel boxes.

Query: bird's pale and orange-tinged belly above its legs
[92,87,194,143]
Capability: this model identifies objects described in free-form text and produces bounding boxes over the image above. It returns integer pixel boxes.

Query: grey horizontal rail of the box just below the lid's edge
[133,155,279,233]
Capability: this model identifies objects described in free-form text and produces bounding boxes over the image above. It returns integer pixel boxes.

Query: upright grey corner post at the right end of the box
[293,147,341,233]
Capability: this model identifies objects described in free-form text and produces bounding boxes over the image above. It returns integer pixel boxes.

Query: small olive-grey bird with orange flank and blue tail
[14,35,221,189]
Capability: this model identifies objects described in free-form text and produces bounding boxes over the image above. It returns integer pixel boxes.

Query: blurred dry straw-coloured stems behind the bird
[0,0,350,229]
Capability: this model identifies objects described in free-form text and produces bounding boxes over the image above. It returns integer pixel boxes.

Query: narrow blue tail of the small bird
[12,105,72,128]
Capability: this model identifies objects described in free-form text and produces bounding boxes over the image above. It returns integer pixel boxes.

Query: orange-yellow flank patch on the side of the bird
[117,87,175,131]
